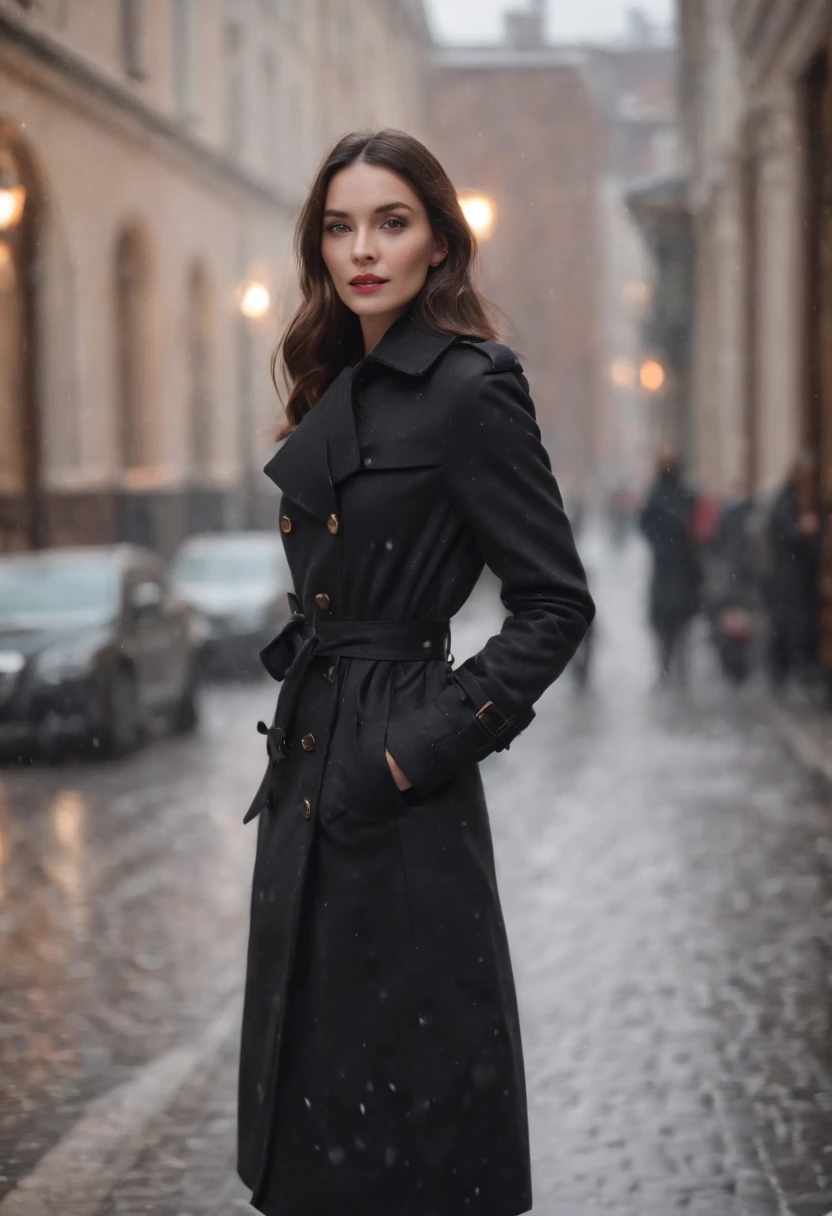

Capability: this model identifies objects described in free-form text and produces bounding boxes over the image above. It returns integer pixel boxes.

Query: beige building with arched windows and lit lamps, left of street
[0,0,429,551]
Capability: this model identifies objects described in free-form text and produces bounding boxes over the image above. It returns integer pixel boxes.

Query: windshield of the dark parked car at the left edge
[0,557,119,620]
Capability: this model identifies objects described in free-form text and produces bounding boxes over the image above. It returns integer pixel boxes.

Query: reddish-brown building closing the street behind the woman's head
[432,5,603,494]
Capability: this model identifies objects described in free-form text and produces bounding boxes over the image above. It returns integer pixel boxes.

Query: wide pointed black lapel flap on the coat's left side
[264,367,358,520]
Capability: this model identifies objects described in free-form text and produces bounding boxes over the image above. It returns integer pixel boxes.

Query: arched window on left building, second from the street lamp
[116,227,151,469]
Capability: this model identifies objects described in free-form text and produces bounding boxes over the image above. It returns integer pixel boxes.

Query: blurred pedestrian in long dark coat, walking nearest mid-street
[640,449,701,681]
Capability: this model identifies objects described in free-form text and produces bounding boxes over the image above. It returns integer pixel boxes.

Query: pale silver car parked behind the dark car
[170,531,292,675]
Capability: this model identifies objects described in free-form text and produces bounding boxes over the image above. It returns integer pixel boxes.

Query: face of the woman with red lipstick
[321,161,448,330]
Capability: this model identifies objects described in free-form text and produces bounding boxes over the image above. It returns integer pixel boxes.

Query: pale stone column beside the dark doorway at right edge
[752,90,803,496]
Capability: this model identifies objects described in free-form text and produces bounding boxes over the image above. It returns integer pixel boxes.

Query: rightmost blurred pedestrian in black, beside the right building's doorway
[765,452,822,688]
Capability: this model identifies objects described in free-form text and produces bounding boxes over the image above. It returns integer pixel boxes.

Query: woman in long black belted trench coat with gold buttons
[238,130,594,1216]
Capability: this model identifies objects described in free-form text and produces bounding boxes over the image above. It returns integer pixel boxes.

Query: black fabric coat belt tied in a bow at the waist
[250,613,450,817]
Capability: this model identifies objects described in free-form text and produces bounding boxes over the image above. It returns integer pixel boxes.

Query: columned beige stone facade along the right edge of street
[679,0,832,500]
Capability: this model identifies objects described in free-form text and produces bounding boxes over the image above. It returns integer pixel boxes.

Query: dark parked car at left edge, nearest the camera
[0,545,199,755]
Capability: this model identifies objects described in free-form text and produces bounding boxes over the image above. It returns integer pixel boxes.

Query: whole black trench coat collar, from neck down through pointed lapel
[264,300,459,522]
